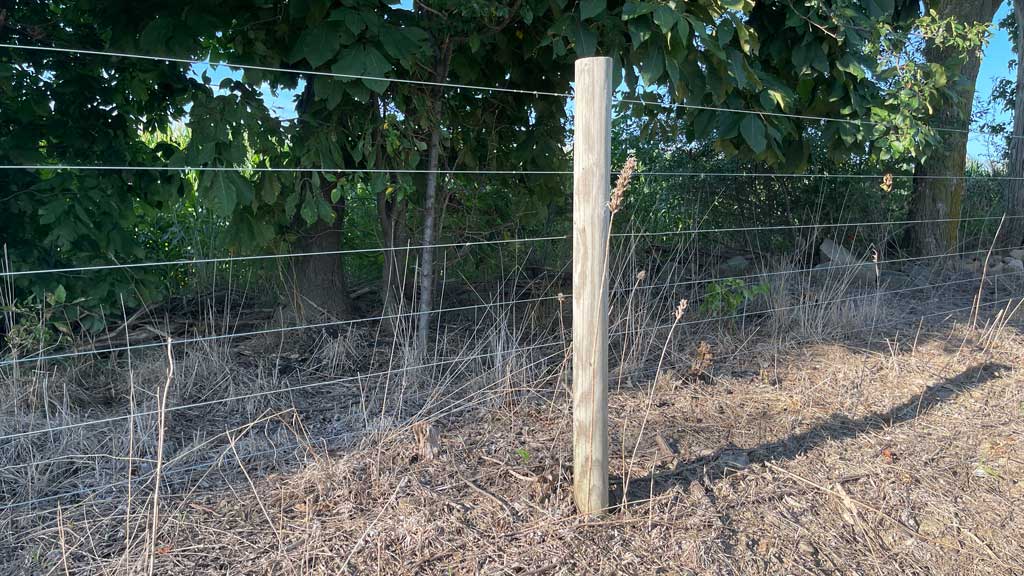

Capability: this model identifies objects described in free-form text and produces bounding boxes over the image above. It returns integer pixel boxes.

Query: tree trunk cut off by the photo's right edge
[998,0,1024,248]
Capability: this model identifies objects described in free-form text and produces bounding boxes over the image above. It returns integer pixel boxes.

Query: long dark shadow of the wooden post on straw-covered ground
[611,362,1010,503]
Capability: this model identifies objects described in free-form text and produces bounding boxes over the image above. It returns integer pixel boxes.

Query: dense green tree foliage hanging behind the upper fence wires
[0,0,1003,340]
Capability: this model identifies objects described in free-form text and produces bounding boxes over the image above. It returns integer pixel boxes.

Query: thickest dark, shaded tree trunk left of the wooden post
[292,175,350,318]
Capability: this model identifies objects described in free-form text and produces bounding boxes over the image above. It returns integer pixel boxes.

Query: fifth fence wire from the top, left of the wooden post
[0,342,562,442]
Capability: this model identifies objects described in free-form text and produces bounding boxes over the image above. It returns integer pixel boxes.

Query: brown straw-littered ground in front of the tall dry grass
[0,268,1024,575]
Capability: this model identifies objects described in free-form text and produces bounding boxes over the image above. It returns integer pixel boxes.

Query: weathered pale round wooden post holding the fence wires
[572,57,612,515]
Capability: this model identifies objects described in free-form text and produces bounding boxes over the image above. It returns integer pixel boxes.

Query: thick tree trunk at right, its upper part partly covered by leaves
[911,0,1001,255]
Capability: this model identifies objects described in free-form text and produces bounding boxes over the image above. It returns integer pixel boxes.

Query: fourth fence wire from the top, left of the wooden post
[0,294,571,368]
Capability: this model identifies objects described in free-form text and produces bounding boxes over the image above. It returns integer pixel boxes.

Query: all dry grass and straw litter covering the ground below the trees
[0,249,1024,575]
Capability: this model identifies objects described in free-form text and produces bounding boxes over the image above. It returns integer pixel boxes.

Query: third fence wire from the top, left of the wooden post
[0,236,568,278]
